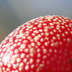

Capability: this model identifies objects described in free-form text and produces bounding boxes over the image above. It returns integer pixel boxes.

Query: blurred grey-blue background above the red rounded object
[0,0,72,42]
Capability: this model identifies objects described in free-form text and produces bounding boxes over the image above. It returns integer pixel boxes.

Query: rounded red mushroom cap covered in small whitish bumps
[0,16,72,72]
